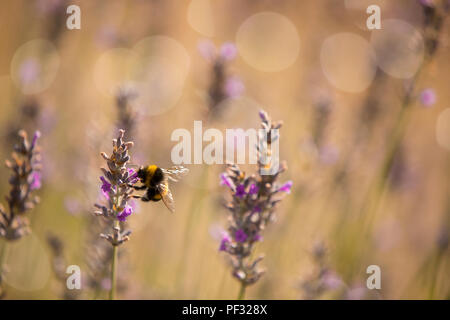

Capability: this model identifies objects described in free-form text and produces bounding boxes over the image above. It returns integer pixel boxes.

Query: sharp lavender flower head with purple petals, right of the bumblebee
[219,111,292,287]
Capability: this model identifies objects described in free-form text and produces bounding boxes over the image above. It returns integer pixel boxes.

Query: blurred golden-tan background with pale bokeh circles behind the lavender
[0,0,450,299]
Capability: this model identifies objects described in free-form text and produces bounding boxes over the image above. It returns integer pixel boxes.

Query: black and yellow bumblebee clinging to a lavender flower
[130,165,189,212]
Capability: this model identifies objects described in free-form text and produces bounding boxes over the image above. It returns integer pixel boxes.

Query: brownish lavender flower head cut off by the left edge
[0,130,41,240]
